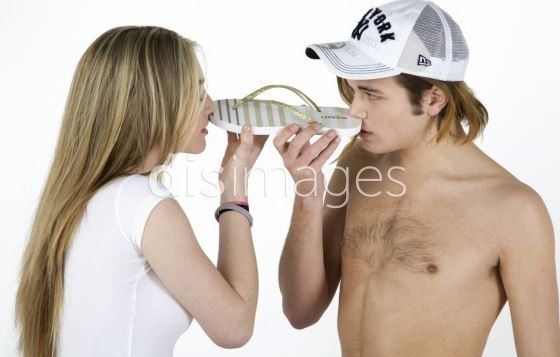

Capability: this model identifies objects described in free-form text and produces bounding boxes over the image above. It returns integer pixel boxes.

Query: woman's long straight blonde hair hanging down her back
[15,26,203,357]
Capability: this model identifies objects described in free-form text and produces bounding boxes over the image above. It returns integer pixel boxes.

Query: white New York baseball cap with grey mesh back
[305,0,469,81]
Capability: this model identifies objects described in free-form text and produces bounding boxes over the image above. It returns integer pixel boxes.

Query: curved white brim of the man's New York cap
[305,41,401,80]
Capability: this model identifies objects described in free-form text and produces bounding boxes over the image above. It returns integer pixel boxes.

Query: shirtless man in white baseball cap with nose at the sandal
[274,1,560,357]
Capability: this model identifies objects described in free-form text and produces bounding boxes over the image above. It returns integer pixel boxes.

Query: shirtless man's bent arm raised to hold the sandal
[276,124,354,329]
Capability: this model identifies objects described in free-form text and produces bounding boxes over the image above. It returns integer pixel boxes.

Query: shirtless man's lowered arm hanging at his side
[500,186,560,357]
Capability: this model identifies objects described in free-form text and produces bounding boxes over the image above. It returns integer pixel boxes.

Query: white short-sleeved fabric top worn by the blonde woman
[58,175,192,357]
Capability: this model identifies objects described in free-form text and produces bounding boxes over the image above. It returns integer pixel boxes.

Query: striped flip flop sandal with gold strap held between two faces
[210,85,362,136]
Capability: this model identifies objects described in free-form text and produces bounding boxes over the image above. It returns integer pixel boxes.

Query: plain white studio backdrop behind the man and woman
[0,0,560,357]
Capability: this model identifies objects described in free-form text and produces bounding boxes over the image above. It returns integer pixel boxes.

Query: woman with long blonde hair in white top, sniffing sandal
[16,27,266,357]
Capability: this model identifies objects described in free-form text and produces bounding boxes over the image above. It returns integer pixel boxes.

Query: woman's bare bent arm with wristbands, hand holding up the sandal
[141,129,267,348]
